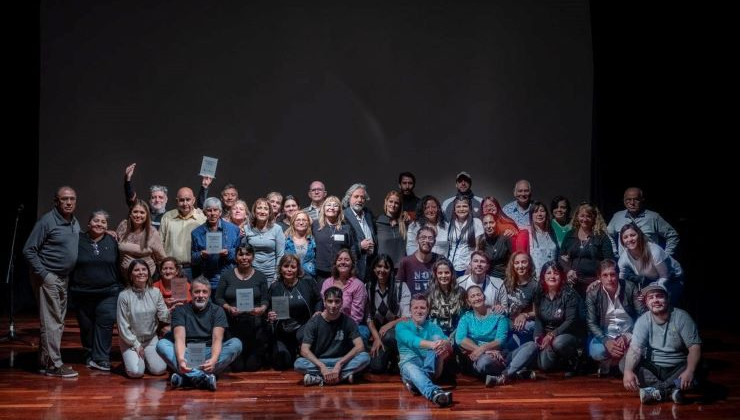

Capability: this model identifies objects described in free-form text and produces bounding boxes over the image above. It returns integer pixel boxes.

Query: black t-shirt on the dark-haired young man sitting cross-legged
[303,314,360,359]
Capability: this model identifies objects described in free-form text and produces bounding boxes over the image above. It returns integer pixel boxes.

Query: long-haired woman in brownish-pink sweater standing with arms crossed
[116,199,167,273]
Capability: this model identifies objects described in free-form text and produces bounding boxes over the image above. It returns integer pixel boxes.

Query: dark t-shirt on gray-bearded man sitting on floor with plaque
[172,302,229,347]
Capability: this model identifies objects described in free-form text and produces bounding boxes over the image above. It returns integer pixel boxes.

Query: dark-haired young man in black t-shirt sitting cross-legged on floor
[293,287,370,386]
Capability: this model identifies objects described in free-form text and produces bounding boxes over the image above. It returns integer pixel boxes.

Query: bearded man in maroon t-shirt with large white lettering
[396,226,441,294]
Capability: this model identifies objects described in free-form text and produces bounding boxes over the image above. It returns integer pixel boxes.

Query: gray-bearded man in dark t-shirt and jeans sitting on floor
[157,277,242,391]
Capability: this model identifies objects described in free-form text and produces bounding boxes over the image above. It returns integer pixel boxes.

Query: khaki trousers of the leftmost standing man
[31,273,69,368]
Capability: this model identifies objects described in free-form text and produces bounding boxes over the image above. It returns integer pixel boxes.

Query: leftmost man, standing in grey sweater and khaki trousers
[23,186,80,378]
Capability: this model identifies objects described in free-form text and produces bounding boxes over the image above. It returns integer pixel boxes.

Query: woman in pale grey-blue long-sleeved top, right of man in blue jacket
[242,197,285,286]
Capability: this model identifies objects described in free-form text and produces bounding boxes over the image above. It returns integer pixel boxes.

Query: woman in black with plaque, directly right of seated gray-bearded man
[214,244,269,372]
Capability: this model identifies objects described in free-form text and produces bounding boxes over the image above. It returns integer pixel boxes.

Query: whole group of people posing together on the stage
[24,168,701,406]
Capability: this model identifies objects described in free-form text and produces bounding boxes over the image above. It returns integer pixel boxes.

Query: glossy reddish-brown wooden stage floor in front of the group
[0,315,740,420]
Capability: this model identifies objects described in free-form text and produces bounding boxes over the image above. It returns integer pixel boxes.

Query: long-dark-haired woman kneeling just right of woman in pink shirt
[365,254,411,373]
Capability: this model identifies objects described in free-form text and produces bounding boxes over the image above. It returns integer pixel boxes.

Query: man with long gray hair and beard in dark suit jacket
[342,183,378,281]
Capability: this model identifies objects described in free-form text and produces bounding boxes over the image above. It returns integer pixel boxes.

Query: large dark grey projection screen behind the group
[38,0,593,224]
